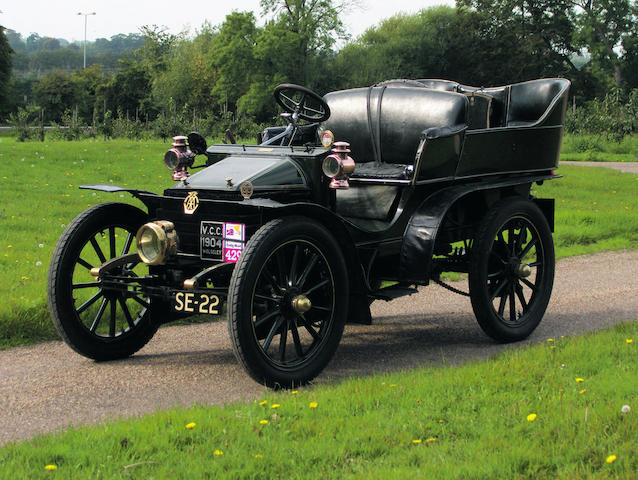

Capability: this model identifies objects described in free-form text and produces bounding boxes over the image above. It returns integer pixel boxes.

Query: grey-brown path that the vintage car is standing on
[0,251,638,444]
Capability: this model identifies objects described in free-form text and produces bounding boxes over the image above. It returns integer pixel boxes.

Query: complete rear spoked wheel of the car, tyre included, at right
[469,199,555,342]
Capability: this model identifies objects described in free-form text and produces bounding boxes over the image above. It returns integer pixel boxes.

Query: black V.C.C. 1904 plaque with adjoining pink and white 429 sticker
[199,221,246,263]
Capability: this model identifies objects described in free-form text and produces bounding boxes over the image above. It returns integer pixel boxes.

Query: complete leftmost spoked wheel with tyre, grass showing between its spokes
[48,203,157,360]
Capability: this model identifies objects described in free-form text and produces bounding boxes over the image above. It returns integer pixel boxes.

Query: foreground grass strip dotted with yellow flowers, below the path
[0,323,638,480]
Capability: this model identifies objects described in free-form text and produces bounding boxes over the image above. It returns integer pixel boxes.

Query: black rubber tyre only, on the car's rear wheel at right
[468,198,555,343]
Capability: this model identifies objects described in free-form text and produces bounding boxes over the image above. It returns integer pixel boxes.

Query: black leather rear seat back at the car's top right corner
[506,78,569,127]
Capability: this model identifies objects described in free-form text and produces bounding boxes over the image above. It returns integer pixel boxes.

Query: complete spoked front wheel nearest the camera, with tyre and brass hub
[228,217,348,388]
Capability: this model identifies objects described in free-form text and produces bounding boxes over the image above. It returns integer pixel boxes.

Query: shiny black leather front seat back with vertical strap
[322,85,468,164]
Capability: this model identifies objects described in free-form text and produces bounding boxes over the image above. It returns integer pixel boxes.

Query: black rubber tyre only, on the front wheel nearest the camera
[228,216,349,389]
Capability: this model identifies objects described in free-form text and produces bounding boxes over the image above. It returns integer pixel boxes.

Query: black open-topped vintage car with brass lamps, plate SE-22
[48,78,570,388]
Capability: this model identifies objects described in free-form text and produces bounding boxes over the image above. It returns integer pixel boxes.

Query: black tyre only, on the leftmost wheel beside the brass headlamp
[47,203,158,361]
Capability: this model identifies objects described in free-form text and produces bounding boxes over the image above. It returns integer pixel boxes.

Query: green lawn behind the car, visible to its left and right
[0,137,638,348]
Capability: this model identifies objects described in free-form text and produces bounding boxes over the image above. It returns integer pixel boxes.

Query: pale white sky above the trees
[0,0,454,41]
